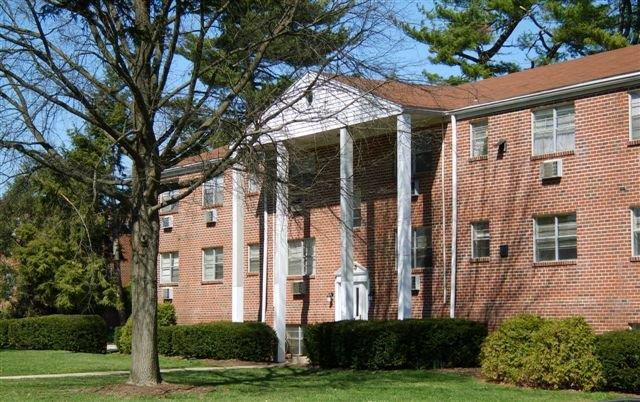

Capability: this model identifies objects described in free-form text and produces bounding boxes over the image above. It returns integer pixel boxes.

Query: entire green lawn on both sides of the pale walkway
[0,351,632,401]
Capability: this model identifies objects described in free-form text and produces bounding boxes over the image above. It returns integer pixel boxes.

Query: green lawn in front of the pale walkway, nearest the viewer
[0,368,632,401]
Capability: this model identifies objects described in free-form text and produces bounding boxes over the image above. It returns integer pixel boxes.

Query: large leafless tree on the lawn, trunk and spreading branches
[0,0,390,385]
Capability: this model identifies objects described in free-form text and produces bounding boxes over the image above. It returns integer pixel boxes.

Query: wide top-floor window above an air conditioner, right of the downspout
[533,105,575,155]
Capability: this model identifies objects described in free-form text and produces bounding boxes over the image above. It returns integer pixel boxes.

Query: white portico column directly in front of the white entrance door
[336,128,354,320]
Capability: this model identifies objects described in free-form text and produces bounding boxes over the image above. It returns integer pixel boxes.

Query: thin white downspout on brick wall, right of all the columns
[449,115,458,318]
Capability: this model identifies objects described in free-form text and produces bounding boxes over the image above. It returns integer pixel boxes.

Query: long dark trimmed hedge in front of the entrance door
[304,318,487,370]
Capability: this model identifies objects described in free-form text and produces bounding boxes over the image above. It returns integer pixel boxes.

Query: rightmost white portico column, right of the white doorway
[396,114,411,320]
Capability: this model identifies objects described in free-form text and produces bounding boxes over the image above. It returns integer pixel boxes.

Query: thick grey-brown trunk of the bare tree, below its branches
[129,192,162,386]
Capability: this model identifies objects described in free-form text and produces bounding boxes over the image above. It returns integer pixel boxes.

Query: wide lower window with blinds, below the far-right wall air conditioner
[535,214,578,261]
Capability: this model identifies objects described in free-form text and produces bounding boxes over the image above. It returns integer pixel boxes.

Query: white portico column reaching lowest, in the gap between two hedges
[273,143,289,362]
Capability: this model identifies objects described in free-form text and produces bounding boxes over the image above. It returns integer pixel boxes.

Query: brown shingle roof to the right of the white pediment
[338,45,640,110]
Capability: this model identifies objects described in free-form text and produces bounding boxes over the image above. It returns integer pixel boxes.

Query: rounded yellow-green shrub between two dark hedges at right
[481,315,604,390]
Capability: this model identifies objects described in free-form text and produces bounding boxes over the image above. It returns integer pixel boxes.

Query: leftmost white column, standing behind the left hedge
[231,166,245,322]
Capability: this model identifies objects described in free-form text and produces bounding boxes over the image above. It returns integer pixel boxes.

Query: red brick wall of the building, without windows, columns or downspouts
[160,88,640,331]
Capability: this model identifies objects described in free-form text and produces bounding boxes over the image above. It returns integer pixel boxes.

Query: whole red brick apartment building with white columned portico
[158,46,640,359]
